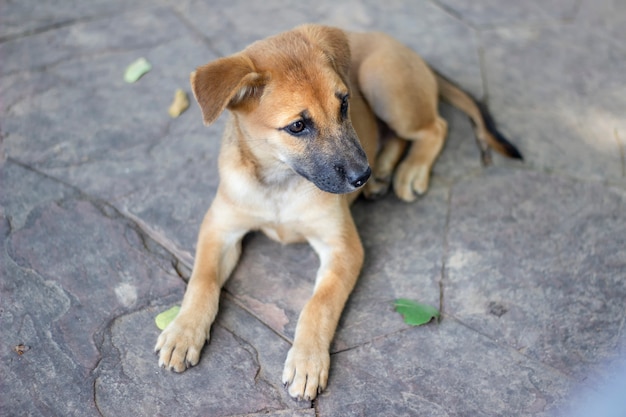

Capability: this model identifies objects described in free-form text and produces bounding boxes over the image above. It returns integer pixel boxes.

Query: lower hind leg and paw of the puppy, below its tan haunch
[393,116,448,202]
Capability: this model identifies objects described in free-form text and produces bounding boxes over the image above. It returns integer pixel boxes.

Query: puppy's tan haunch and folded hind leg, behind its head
[352,34,447,201]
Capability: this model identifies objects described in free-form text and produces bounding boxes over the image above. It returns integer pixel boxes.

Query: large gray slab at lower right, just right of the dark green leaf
[444,169,626,378]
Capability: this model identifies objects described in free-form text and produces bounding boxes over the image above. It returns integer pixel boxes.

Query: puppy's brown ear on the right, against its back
[297,24,350,81]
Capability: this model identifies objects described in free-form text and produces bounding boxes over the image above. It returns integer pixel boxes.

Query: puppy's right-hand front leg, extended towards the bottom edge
[283,216,363,400]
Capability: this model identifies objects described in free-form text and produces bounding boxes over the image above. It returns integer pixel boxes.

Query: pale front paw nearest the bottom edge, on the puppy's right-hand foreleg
[283,346,330,401]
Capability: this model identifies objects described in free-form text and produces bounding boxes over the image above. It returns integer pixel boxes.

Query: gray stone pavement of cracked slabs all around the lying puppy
[0,0,626,417]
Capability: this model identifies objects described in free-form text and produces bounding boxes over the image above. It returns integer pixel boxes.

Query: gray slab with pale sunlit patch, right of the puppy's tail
[483,25,626,180]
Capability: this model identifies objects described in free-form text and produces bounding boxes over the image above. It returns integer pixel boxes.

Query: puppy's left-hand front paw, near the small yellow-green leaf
[154,315,209,372]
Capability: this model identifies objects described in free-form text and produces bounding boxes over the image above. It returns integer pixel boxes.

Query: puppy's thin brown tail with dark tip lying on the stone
[435,73,524,165]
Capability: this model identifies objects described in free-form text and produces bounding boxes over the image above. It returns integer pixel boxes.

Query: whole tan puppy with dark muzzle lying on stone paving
[155,25,521,400]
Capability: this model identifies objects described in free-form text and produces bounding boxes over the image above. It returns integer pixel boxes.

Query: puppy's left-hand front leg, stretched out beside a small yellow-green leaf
[155,202,245,372]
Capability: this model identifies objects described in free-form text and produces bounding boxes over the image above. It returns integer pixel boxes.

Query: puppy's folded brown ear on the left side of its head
[190,54,267,125]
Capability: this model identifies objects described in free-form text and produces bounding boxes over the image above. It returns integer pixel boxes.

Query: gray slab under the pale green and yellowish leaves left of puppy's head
[0,8,217,199]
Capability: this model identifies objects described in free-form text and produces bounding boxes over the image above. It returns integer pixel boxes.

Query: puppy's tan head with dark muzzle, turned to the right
[191,25,371,193]
